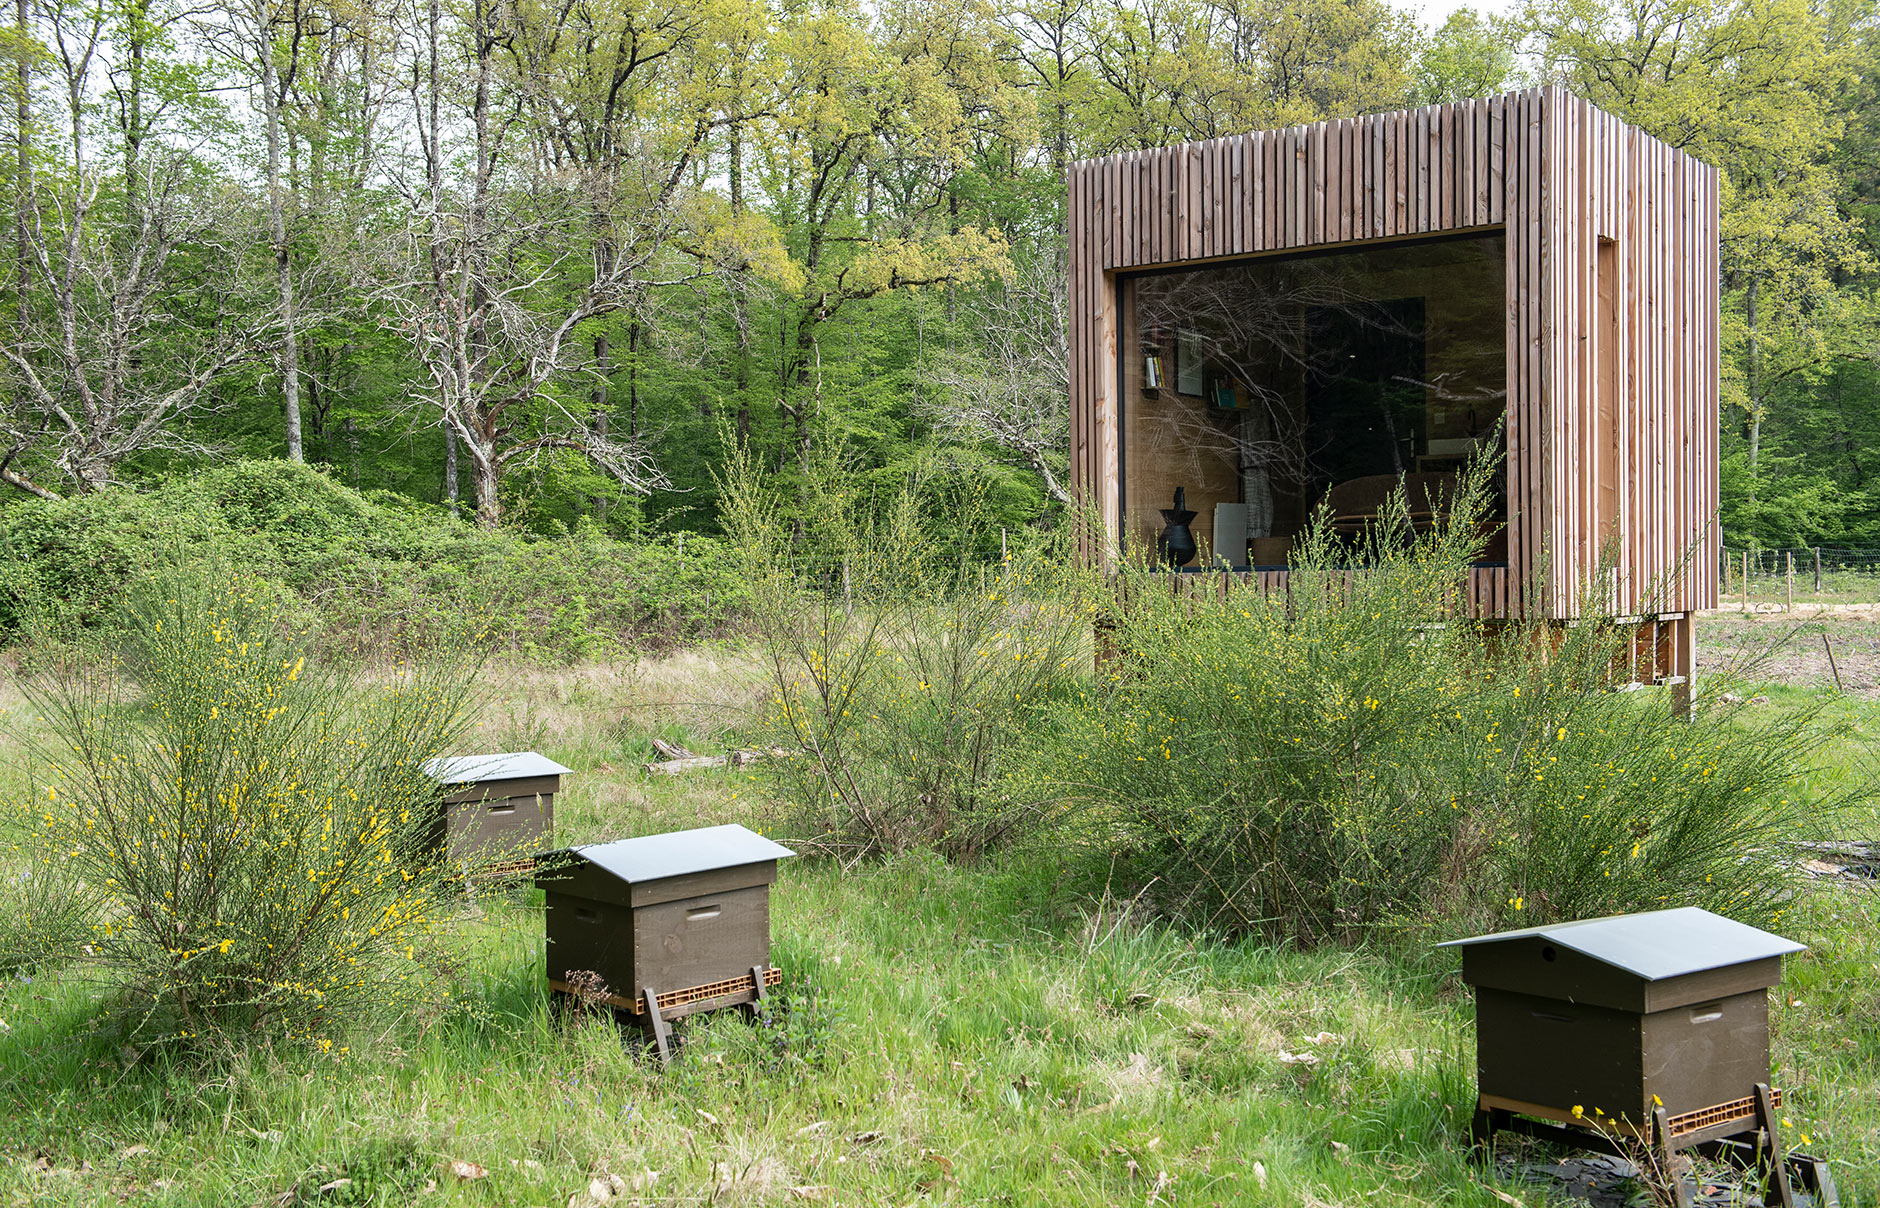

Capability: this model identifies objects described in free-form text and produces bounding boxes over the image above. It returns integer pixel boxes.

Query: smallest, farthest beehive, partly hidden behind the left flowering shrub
[425,751,568,862]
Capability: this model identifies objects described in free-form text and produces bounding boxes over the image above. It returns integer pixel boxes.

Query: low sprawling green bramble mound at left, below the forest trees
[0,462,748,661]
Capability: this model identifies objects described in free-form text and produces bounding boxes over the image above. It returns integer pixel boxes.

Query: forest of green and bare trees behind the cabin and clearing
[0,0,1880,547]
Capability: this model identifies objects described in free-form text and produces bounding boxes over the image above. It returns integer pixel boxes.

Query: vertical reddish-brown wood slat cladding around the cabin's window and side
[1068,88,1720,623]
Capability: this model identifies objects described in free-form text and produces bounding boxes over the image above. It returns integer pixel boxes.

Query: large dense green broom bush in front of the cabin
[1026,464,1816,943]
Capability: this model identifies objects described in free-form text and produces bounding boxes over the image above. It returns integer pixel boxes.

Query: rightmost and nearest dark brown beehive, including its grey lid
[1442,907,1805,1127]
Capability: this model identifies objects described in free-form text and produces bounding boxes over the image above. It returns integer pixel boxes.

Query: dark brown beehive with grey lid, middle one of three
[538,825,795,1044]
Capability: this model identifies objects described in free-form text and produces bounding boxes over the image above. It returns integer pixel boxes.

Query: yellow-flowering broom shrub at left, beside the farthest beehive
[21,569,481,1046]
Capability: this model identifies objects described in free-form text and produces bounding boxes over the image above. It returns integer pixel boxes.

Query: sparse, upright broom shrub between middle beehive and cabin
[722,443,1094,859]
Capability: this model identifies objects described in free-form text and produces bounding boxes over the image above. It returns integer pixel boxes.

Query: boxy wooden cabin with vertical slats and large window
[1068,88,1720,695]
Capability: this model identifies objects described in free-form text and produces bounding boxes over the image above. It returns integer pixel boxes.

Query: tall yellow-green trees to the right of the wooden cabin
[1517,0,1880,543]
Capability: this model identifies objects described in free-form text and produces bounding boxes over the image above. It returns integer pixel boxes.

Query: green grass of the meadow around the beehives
[0,653,1880,1208]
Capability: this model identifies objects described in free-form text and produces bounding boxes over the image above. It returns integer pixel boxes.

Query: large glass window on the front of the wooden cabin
[1120,235,1508,567]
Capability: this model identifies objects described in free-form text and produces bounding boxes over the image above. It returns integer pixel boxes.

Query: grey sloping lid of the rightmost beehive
[1436,906,1809,981]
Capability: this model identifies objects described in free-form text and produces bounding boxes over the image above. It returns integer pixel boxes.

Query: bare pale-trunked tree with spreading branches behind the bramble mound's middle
[380,0,774,526]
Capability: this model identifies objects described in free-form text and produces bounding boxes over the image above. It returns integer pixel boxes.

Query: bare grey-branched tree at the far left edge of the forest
[0,13,271,496]
